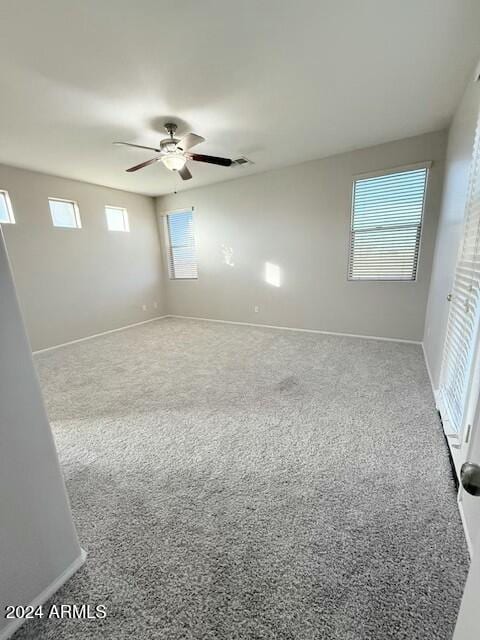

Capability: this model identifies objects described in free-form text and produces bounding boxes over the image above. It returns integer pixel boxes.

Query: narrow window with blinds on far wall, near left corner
[166,210,198,280]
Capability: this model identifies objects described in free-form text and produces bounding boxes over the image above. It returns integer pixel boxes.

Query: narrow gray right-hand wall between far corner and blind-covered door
[424,74,480,388]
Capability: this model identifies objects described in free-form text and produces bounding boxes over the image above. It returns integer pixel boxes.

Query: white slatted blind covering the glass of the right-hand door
[440,115,480,432]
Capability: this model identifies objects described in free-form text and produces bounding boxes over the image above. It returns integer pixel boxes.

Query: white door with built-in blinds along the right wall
[437,110,480,474]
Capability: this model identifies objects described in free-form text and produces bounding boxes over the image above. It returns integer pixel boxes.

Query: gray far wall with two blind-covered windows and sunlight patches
[157,127,446,340]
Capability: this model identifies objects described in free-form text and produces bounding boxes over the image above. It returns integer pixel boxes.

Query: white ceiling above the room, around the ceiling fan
[0,0,480,195]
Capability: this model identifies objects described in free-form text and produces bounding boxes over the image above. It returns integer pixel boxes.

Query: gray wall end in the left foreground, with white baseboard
[0,231,81,636]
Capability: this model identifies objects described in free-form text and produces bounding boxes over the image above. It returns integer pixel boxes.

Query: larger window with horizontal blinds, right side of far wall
[348,164,429,281]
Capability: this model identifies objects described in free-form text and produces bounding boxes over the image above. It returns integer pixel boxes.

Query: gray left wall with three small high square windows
[0,160,165,350]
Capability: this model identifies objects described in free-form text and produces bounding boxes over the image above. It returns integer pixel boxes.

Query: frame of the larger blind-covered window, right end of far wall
[347,160,433,284]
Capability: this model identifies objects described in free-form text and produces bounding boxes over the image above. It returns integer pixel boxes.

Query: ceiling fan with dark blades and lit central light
[113,122,234,180]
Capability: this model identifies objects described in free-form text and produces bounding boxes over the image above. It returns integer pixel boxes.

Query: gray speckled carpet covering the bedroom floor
[14,319,468,640]
